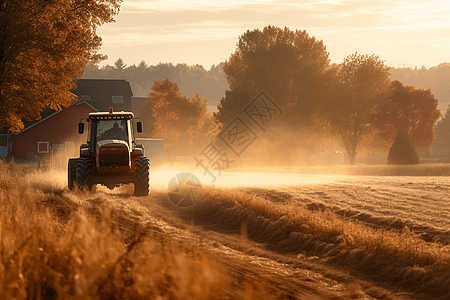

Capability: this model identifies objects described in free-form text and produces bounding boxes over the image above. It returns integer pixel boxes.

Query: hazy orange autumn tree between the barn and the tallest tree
[149,78,218,155]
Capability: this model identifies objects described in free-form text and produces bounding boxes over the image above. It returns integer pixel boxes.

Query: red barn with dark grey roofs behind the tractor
[0,79,137,161]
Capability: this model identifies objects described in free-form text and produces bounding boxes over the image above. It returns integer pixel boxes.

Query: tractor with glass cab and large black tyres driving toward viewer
[68,108,150,196]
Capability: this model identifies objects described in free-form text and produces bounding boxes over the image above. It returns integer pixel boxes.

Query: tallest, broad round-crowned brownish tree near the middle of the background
[219,26,329,124]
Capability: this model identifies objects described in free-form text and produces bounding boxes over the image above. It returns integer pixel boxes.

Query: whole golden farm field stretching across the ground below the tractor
[0,162,450,299]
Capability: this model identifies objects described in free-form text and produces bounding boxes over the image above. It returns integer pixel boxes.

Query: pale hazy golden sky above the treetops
[98,0,450,69]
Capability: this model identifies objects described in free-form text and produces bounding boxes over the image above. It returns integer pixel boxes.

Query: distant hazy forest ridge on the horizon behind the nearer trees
[83,58,450,116]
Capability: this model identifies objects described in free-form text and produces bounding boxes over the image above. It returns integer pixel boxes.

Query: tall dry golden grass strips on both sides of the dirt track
[0,161,450,299]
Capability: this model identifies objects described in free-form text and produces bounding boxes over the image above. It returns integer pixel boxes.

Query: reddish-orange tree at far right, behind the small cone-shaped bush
[376,80,441,149]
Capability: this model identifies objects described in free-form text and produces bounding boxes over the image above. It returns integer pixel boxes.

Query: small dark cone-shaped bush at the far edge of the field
[387,132,419,165]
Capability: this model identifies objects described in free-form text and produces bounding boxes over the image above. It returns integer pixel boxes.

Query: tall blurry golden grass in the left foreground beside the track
[0,162,243,299]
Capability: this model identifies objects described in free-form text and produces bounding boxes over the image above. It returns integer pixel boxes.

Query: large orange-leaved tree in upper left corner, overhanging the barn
[0,0,122,132]
